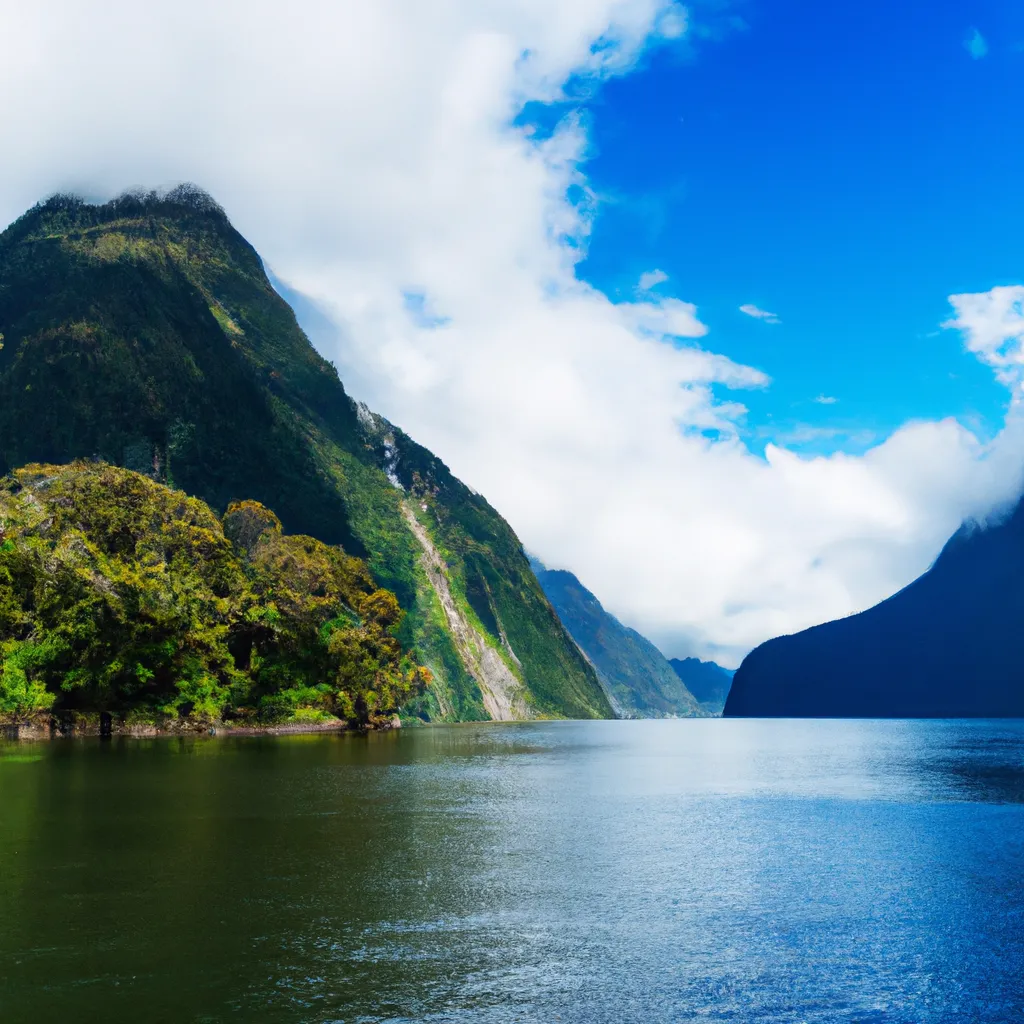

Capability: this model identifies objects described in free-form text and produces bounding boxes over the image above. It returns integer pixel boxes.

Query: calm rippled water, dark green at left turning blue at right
[0,720,1024,1024]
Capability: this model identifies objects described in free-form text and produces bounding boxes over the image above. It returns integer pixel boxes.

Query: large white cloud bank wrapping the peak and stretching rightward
[0,0,1020,662]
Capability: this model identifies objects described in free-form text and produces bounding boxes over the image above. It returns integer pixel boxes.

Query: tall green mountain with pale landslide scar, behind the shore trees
[0,186,612,720]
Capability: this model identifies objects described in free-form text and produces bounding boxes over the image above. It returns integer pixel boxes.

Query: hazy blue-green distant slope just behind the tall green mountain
[530,559,700,718]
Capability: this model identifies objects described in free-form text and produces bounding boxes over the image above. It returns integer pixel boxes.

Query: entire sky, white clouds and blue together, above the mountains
[0,0,1024,667]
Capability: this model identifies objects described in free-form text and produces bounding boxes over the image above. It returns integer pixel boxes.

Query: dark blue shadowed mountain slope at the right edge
[725,504,1024,718]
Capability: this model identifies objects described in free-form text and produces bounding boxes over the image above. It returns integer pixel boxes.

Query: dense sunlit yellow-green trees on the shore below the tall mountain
[0,463,429,724]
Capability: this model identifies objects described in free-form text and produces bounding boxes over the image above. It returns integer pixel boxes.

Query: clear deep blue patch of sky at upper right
[529,0,1024,451]
